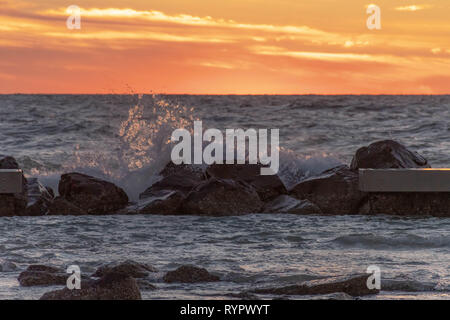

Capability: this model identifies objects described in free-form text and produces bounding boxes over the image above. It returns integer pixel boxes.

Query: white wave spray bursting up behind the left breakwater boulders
[55,95,195,200]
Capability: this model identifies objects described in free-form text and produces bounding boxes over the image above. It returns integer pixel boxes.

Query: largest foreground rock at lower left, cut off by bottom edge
[40,272,142,300]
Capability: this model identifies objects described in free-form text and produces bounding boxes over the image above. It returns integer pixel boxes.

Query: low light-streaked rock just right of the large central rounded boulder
[264,195,322,214]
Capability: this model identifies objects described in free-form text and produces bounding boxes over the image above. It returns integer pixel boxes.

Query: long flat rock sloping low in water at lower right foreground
[251,274,379,297]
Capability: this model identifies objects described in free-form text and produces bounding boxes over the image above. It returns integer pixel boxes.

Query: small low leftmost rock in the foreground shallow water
[18,265,69,287]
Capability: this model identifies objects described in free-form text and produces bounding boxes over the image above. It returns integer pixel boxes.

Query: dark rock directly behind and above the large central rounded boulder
[206,164,287,201]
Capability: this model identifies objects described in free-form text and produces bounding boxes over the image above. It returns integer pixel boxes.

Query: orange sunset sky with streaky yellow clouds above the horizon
[0,0,450,94]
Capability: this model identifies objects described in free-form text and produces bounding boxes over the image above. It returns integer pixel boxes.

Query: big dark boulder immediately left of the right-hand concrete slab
[290,166,367,214]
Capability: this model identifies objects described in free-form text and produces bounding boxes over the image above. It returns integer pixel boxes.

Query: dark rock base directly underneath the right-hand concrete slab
[359,192,450,217]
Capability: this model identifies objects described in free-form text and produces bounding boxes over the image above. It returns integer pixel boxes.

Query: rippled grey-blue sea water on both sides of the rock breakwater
[0,95,450,299]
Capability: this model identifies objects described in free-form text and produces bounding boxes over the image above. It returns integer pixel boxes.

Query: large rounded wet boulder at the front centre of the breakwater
[182,178,264,216]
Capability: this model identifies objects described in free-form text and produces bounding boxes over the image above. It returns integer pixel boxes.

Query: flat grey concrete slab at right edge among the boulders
[359,168,450,192]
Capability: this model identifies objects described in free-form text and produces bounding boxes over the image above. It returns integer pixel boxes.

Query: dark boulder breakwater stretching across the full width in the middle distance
[0,140,450,217]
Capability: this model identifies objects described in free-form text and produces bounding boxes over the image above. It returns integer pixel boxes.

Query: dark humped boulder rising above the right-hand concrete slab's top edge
[350,140,430,170]
